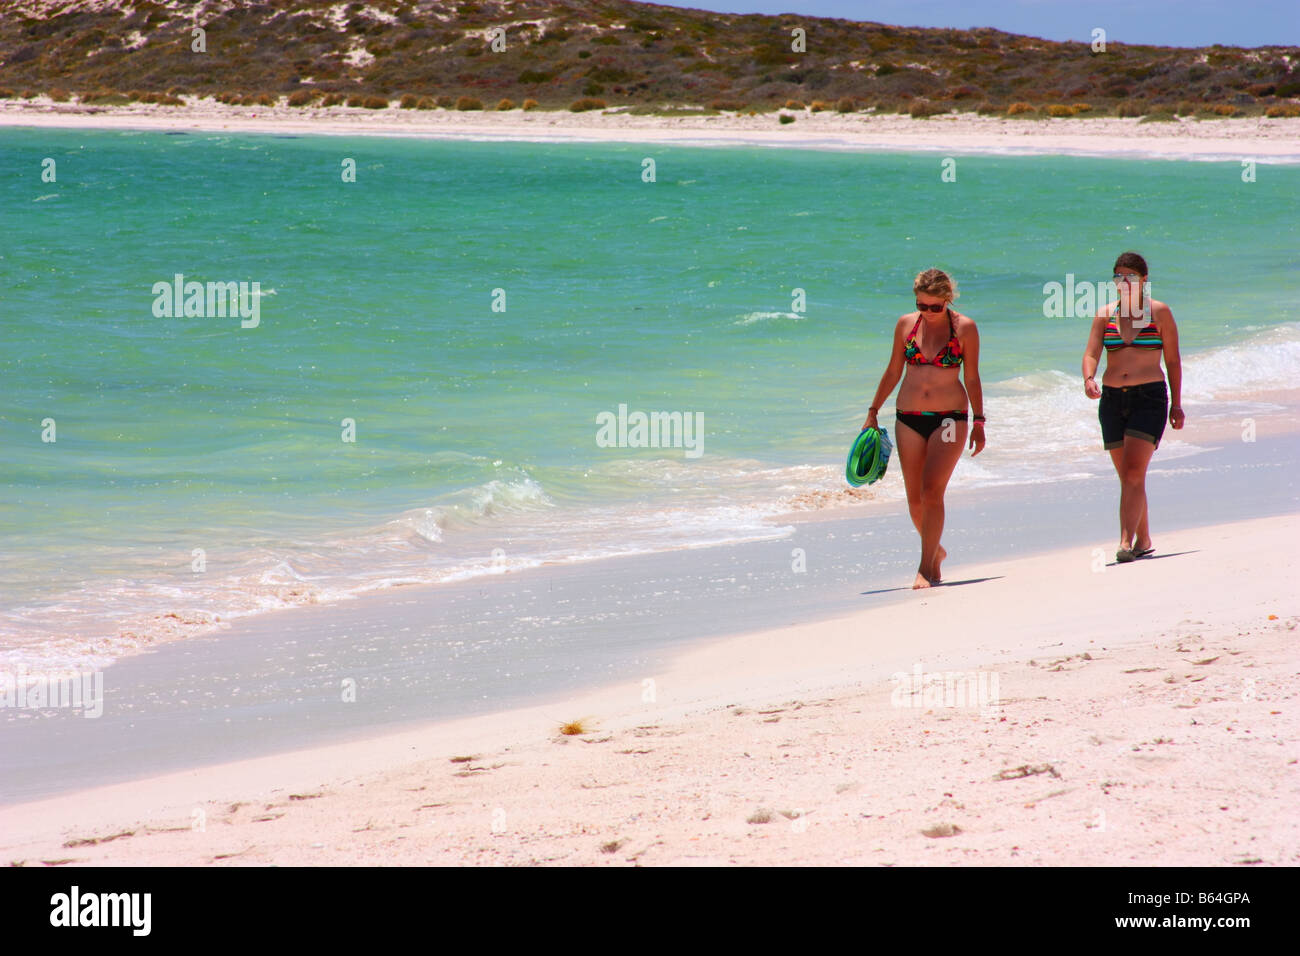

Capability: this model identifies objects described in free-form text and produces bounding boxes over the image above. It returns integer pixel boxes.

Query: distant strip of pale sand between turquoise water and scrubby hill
[0,98,1300,164]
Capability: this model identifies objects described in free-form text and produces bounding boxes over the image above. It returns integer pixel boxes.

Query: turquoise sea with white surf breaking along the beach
[0,130,1300,659]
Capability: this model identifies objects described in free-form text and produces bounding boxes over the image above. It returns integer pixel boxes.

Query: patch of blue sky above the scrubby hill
[667,0,1300,47]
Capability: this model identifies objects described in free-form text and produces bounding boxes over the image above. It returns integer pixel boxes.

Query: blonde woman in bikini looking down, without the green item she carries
[863,269,984,588]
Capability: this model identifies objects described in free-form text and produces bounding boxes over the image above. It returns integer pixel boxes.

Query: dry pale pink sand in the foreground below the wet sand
[0,514,1300,865]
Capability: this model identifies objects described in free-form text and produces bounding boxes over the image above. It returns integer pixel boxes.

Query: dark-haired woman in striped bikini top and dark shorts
[1083,252,1186,563]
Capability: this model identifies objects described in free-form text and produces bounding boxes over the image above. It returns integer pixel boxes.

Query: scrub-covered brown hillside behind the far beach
[0,0,1300,120]
